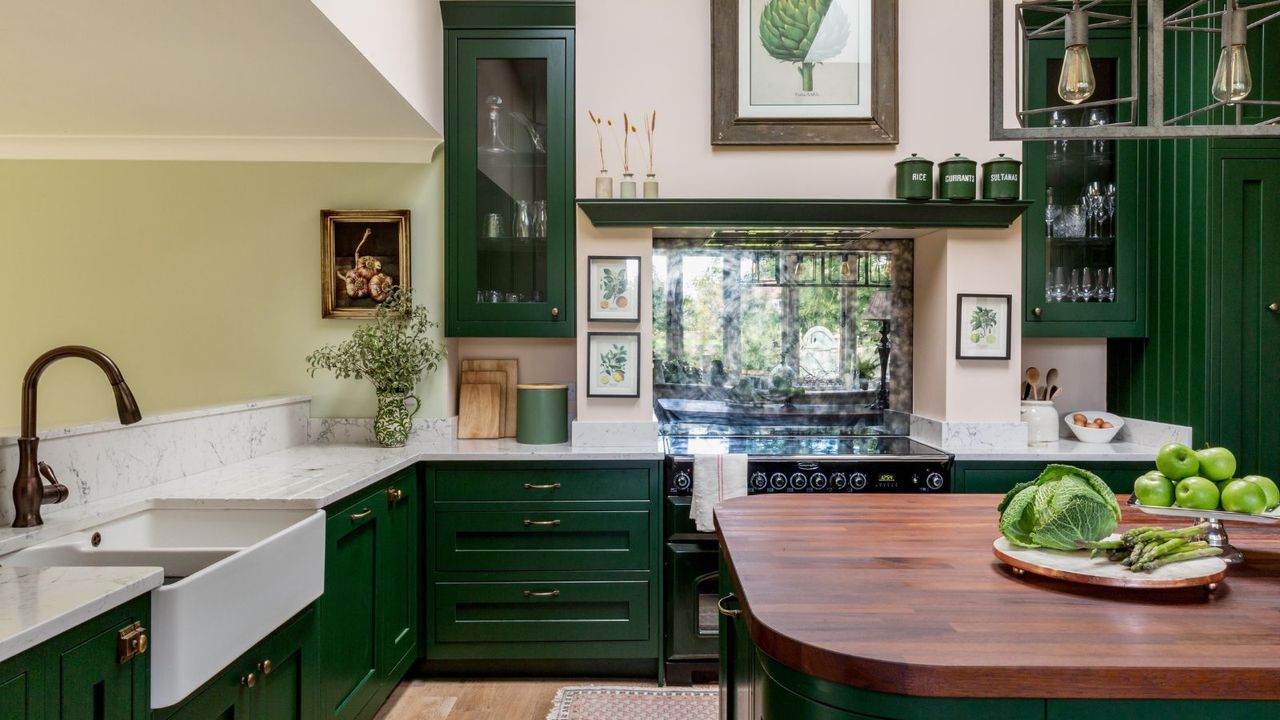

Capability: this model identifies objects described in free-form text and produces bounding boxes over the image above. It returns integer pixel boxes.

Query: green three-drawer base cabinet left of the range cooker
[422,461,662,675]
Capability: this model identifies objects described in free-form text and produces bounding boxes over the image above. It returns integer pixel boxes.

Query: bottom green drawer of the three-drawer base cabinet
[430,580,649,643]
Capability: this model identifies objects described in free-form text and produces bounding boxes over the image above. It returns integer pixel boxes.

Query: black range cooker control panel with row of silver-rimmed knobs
[664,456,951,495]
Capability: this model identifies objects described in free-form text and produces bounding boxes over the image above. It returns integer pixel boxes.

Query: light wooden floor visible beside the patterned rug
[374,678,655,720]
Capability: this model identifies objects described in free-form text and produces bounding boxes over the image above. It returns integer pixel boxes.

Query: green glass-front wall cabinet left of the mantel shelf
[440,0,576,337]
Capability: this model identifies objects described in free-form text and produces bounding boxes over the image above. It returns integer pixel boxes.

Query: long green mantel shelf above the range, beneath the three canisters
[577,199,1030,228]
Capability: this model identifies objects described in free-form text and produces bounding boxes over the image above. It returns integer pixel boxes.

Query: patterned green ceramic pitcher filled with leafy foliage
[307,287,444,447]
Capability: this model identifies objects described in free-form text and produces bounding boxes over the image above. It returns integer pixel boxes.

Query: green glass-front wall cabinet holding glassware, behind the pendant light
[1023,32,1147,337]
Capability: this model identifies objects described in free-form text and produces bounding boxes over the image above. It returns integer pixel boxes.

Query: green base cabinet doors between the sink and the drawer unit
[319,469,421,720]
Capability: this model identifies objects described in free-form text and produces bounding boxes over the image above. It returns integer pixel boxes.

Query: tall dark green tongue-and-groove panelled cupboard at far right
[1107,15,1280,477]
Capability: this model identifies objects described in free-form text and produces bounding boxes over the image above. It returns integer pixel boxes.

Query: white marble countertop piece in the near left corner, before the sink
[0,568,164,661]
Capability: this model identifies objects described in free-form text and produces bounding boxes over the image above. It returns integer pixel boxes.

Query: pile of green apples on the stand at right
[1133,442,1280,515]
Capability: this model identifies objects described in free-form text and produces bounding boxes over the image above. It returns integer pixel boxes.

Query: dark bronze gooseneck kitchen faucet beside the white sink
[13,345,142,528]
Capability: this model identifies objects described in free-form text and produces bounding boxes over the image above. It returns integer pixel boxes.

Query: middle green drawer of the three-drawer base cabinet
[434,510,650,573]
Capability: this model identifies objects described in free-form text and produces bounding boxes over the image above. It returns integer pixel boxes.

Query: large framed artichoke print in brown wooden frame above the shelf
[712,0,897,145]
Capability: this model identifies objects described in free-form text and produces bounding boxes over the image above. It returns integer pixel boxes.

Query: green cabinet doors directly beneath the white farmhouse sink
[156,606,321,720]
